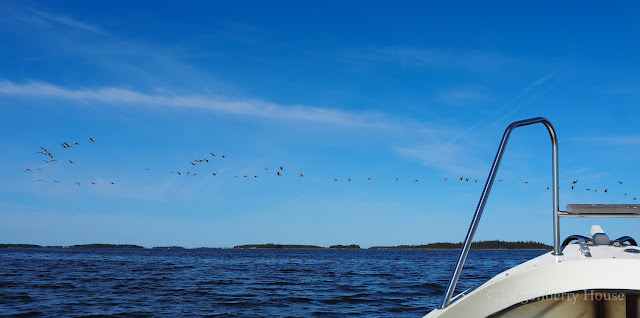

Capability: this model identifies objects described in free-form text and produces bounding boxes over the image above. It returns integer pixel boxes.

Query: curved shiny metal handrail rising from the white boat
[440,117,562,309]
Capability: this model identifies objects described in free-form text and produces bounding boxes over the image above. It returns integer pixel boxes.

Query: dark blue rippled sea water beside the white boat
[0,249,544,317]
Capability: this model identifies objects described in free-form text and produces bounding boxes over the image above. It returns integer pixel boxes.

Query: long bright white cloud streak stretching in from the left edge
[0,80,392,128]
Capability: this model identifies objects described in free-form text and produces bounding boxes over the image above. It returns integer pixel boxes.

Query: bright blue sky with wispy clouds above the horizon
[0,1,640,247]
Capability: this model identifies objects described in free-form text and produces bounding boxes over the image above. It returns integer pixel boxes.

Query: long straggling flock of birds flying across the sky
[24,138,637,201]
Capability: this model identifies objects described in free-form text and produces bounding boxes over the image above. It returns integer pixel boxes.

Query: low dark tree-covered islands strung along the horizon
[0,240,551,250]
